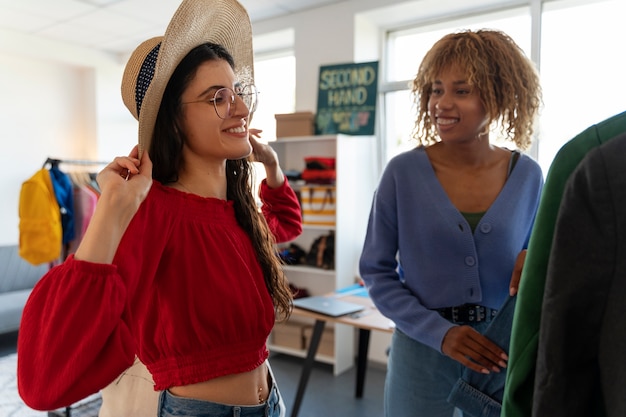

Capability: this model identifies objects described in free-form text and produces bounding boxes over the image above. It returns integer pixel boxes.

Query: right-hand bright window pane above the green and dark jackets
[538,0,626,175]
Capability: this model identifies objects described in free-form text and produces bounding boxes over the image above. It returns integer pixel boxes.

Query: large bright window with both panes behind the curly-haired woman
[381,0,626,175]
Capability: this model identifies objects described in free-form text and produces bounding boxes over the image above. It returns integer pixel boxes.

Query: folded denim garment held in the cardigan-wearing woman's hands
[448,297,517,417]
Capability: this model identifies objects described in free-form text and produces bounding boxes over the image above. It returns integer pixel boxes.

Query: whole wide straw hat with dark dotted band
[122,0,254,157]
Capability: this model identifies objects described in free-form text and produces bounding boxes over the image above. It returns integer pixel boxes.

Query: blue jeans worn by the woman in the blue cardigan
[384,322,488,417]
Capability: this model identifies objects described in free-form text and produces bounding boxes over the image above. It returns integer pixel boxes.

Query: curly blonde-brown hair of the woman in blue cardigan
[411,29,542,150]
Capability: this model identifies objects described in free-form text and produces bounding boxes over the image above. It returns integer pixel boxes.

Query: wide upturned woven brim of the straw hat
[134,0,254,157]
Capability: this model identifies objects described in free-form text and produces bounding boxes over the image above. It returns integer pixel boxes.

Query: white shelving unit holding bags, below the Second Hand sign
[269,135,378,375]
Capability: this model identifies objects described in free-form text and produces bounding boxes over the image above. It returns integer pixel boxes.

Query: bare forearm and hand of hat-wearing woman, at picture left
[74,146,152,263]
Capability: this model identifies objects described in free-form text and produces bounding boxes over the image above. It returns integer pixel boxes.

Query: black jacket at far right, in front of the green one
[532,134,626,417]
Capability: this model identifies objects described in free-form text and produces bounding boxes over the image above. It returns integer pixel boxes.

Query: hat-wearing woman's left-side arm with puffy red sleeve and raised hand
[18,147,152,410]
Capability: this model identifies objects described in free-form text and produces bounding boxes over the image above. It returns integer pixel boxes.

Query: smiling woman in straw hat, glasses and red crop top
[18,0,301,416]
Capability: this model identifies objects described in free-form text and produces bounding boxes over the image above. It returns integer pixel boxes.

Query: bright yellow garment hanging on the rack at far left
[18,168,62,265]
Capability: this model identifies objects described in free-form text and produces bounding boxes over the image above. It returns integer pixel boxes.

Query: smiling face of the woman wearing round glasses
[181,59,252,164]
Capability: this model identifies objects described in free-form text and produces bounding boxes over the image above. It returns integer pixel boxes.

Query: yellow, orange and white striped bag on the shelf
[300,184,336,227]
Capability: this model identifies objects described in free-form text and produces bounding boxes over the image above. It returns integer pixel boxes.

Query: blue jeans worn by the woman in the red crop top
[157,364,285,417]
